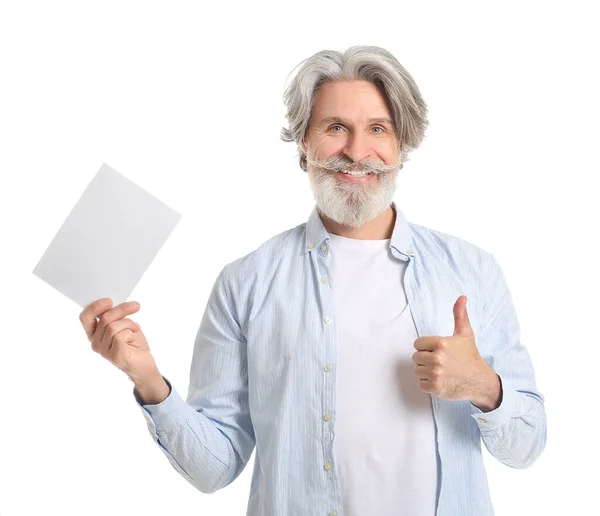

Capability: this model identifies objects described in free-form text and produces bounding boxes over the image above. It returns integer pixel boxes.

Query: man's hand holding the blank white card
[79,298,170,404]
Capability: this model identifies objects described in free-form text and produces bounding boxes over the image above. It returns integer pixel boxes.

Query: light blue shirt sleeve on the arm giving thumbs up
[471,253,546,468]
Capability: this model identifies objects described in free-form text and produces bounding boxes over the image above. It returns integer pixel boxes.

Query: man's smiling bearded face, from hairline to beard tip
[302,80,400,227]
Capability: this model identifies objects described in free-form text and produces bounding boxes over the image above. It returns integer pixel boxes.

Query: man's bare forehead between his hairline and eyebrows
[312,80,391,122]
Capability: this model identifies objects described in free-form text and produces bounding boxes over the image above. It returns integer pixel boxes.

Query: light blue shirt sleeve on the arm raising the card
[134,266,255,493]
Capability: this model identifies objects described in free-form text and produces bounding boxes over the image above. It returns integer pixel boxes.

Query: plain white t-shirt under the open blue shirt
[327,234,438,516]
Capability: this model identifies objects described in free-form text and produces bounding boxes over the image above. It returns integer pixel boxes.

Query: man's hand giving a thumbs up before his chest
[412,296,502,412]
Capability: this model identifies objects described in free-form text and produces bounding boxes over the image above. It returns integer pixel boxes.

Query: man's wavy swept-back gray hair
[281,45,429,171]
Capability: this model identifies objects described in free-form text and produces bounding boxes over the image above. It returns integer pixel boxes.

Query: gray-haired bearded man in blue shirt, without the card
[80,46,546,516]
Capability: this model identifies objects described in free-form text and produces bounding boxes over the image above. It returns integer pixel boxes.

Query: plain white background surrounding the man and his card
[0,0,600,516]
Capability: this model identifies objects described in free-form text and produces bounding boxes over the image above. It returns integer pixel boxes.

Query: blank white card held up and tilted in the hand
[33,163,181,308]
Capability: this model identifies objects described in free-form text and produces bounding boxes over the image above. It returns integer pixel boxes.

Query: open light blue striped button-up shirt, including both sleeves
[134,203,546,516]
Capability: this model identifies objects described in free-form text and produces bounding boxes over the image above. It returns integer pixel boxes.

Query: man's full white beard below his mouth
[308,166,399,228]
